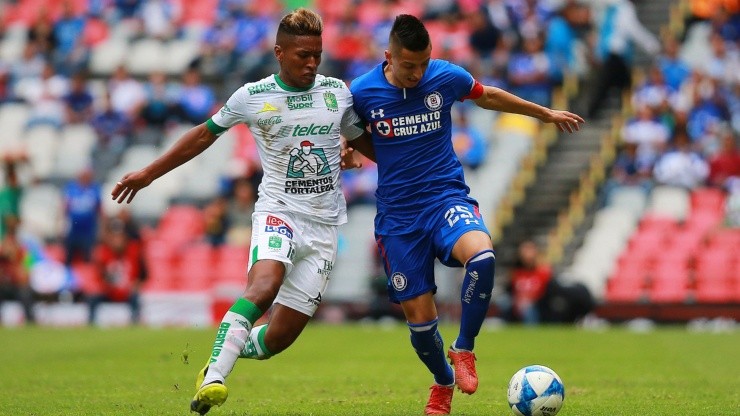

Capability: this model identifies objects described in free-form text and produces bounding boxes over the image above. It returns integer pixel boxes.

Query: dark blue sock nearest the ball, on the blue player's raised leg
[454,250,496,351]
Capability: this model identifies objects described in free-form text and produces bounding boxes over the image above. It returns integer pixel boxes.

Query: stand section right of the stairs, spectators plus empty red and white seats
[569,0,740,305]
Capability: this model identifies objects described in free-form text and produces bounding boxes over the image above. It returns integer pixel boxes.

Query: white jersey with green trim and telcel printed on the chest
[206,75,364,225]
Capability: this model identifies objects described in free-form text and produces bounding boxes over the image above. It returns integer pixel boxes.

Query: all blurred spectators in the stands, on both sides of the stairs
[0,0,740,321]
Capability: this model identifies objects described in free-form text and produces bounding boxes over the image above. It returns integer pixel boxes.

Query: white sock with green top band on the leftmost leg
[203,298,263,385]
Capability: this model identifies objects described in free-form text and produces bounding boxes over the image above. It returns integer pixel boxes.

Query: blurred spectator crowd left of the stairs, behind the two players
[0,0,590,322]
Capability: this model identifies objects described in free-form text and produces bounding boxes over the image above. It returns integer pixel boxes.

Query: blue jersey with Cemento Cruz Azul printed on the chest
[350,60,477,234]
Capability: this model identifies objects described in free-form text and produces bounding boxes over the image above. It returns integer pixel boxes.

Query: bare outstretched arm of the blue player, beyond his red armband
[474,86,585,133]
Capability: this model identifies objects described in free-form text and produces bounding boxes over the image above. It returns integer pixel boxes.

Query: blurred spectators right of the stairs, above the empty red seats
[604,1,740,220]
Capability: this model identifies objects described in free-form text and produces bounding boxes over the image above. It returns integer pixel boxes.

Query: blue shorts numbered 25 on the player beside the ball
[375,199,490,303]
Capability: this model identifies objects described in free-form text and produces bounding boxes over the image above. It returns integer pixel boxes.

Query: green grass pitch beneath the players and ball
[0,324,740,416]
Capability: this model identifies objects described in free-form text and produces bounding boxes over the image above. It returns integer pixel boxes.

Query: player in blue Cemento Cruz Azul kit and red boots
[350,15,584,414]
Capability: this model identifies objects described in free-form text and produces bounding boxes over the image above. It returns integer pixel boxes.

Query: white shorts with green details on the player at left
[249,212,339,316]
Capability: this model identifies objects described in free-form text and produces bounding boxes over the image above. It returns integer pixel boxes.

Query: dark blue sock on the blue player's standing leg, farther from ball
[408,319,455,386]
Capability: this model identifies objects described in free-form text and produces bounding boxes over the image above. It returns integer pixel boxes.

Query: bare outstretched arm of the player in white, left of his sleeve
[111,123,218,204]
